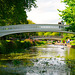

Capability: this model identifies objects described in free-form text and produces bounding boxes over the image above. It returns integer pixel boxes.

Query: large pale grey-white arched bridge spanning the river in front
[0,24,74,37]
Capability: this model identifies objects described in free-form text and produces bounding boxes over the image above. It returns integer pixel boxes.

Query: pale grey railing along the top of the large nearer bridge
[0,24,66,30]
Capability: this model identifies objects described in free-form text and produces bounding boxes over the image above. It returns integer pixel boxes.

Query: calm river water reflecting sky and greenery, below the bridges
[0,45,75,75]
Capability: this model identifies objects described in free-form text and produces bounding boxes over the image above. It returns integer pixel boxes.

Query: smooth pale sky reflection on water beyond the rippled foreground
[38,45,66,58]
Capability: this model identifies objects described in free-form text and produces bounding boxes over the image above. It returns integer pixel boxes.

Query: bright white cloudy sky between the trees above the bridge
[27,0,65,24]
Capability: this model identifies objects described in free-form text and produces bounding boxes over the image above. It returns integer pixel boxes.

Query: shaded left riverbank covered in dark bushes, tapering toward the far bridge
[0,39,46,54]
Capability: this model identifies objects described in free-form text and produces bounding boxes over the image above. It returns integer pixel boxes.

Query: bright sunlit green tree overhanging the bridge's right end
[58,0,75,31]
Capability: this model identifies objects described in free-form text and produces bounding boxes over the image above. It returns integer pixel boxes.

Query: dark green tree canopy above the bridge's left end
[0,0,36,26]
